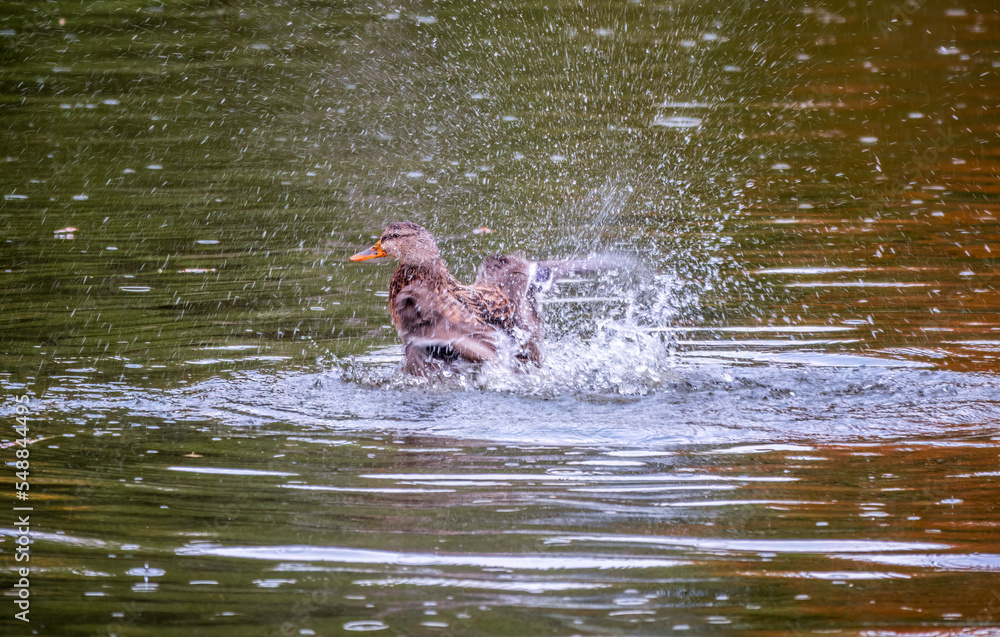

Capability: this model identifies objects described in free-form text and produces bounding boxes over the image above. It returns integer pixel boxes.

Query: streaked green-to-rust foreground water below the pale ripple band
[4,417,998,634]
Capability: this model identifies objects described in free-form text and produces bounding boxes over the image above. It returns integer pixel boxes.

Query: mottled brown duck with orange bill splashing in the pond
[350,221,555,377]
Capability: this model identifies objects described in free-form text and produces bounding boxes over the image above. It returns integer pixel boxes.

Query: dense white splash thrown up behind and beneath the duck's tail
[339,176,713,395]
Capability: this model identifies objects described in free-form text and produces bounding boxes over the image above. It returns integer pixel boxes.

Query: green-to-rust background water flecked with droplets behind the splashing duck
[0,2,998,384]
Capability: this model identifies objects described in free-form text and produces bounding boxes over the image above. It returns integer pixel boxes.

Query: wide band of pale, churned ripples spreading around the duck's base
[25,360,1000,444]
